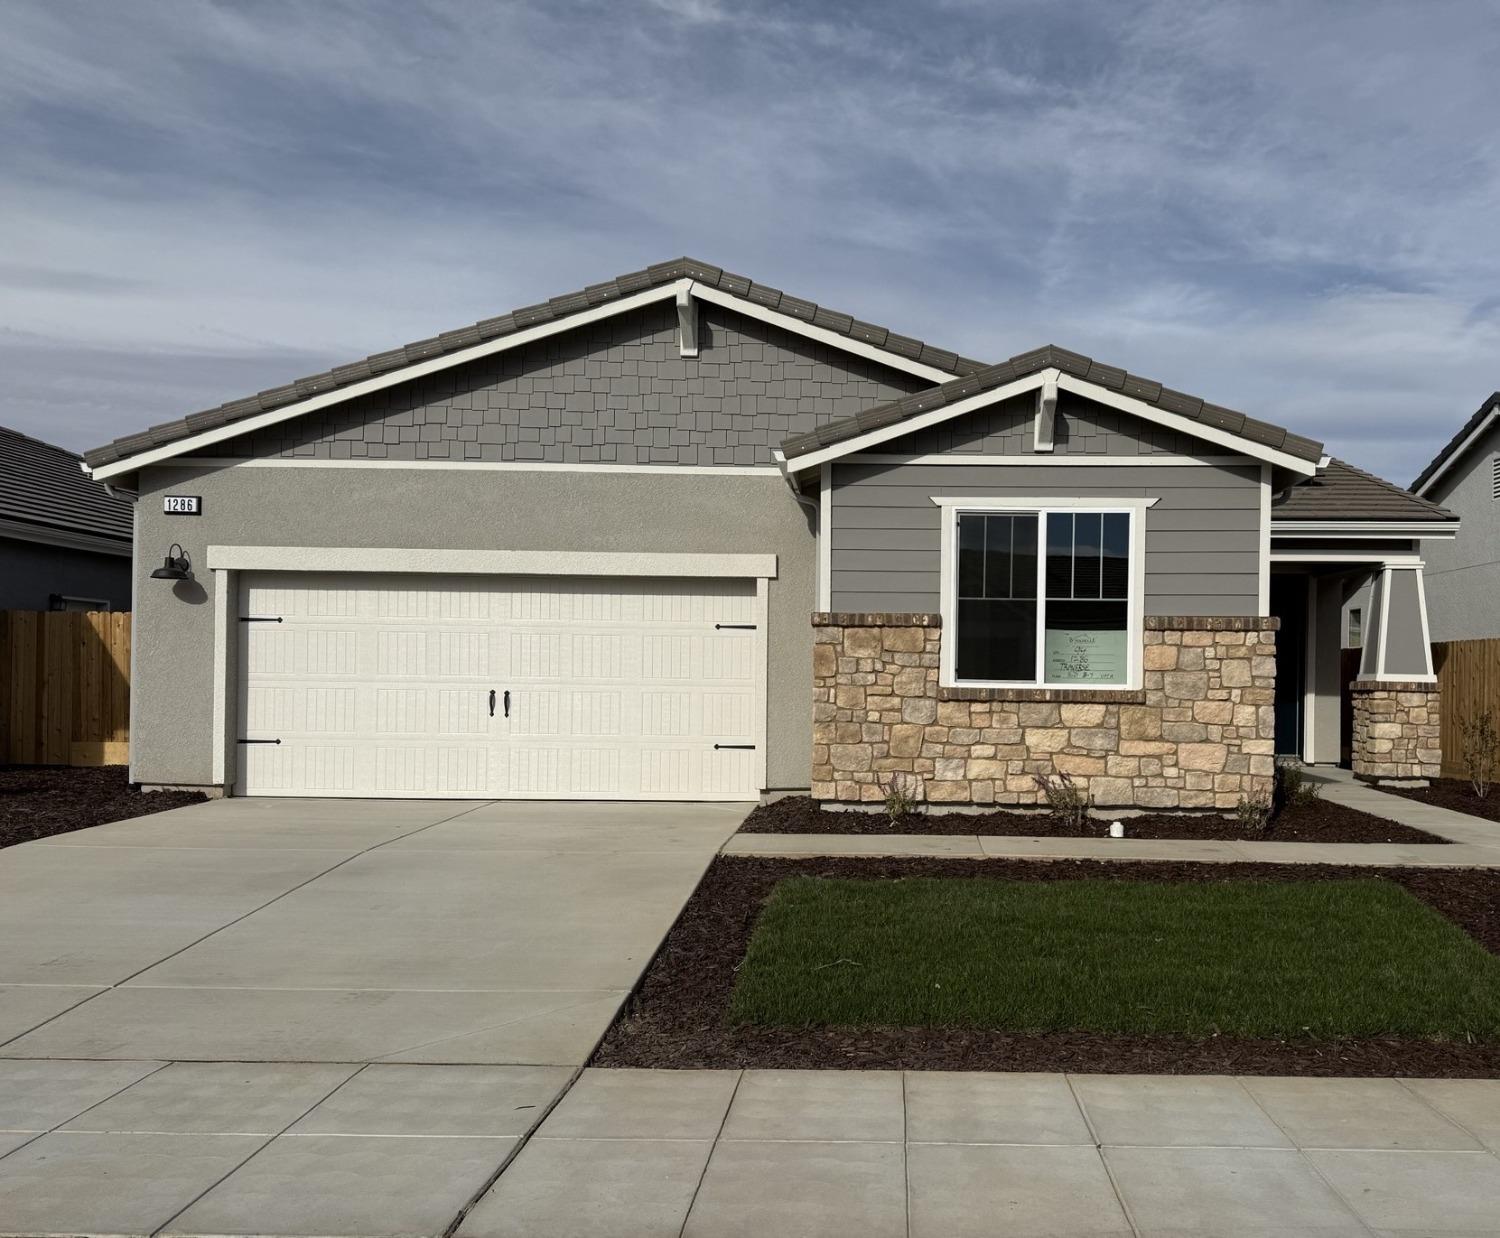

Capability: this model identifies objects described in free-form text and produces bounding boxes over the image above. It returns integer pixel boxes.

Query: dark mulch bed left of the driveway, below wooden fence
[0,765,207,846]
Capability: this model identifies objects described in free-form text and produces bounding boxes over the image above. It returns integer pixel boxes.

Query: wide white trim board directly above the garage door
[209,546,776,579]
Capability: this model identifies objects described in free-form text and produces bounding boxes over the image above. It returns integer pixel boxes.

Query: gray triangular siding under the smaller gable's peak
[894,392,1200,456]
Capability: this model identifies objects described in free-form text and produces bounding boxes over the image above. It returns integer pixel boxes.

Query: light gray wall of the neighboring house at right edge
[1422,425,1500,641]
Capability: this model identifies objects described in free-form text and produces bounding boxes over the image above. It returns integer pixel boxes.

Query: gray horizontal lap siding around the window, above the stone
[831,464,1260,615]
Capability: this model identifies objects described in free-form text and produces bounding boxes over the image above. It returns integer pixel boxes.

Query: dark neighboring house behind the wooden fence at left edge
[0,426,132,611]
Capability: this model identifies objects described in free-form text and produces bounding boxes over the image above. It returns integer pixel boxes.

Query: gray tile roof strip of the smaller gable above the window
[782,344,1323,468]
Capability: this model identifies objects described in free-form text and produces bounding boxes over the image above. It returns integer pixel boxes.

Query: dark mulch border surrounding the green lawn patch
[591,855,1500,1079]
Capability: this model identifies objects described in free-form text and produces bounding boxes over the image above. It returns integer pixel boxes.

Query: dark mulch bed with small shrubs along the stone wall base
[740,795,1449,843]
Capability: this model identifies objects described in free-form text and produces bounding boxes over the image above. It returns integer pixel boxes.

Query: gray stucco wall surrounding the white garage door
[131,465,816,788]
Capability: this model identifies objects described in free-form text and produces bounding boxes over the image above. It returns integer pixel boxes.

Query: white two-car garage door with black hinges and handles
[237,572,765,800]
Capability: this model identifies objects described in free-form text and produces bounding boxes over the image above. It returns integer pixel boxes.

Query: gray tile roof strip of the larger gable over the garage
[84,258,983,468]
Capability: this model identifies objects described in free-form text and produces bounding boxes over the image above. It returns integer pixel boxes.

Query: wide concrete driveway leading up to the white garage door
[0,800,750,1235]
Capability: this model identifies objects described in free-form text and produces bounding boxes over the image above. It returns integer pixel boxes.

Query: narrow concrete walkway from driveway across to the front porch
[723,768,1500,869]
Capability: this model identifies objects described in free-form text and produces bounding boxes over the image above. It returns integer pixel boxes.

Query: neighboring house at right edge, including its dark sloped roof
[1412,392,1500,641]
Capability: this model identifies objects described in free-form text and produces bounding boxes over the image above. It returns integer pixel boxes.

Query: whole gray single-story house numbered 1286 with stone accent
[86,258,1458,807]
